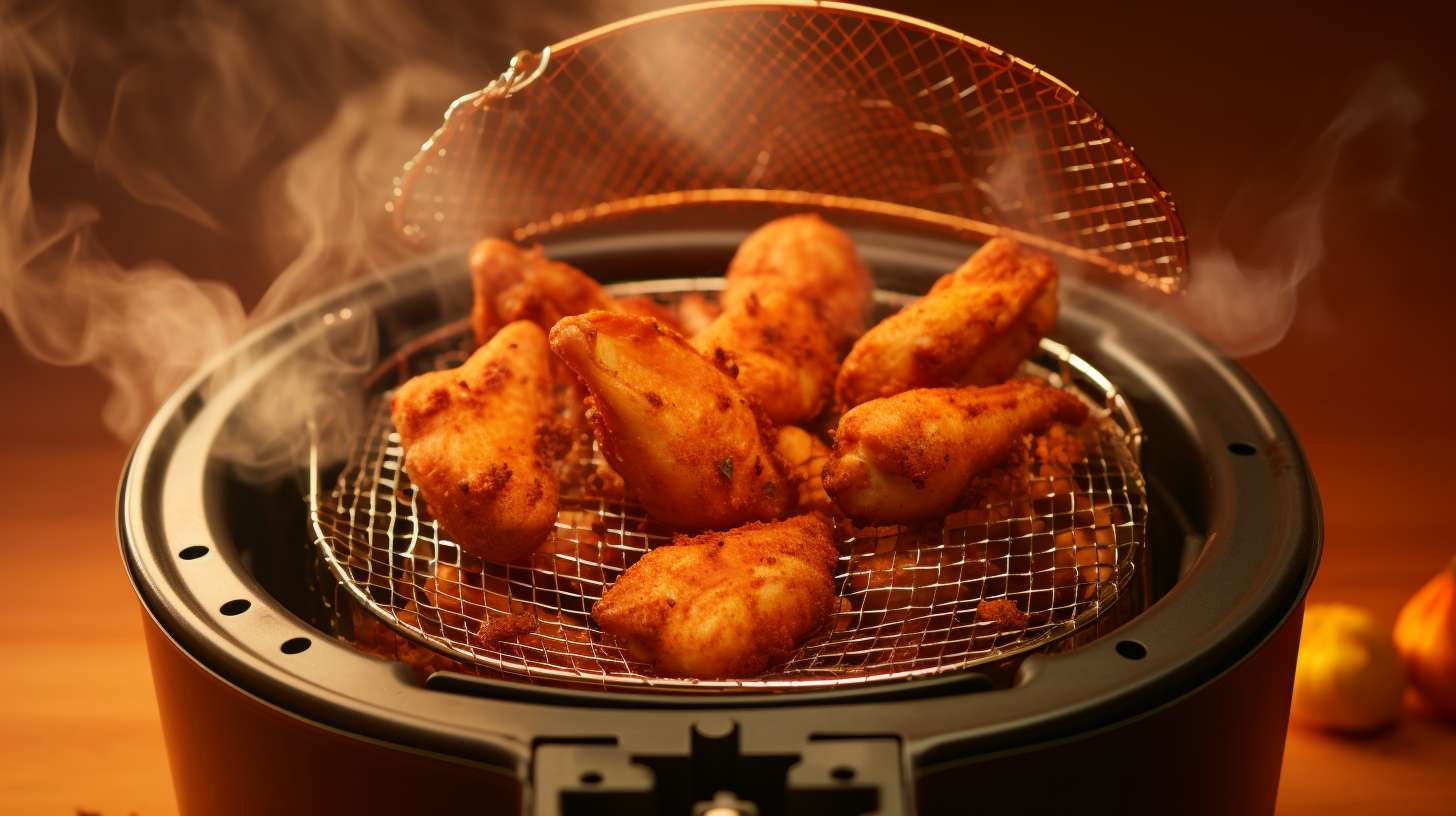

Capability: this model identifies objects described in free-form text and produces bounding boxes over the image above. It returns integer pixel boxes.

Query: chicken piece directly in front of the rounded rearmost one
[692,287,837,424]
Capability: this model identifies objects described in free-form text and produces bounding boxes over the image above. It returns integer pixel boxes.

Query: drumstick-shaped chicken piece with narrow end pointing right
[824,380,1088,523]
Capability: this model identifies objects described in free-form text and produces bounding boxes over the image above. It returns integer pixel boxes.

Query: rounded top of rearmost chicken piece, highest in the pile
[722,214,875,350]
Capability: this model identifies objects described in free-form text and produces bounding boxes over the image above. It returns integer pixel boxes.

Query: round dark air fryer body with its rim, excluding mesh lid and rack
[119,232,1321,815]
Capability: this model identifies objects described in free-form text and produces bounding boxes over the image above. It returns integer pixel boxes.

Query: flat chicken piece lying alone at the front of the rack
[591,514,837,678]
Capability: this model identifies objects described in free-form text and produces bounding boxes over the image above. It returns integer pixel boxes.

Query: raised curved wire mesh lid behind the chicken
[386,1,1188,291]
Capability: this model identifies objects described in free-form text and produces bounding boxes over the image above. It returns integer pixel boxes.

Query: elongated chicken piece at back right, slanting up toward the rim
[834,238,1057,409]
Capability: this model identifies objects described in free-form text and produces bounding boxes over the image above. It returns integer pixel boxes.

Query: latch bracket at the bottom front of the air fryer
[531,717,907,816]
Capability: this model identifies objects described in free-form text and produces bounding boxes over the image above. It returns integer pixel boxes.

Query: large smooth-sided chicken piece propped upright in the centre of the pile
[550,312,794,529]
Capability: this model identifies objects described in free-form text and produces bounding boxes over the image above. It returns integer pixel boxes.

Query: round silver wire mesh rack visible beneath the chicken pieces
[310,278,1147,691]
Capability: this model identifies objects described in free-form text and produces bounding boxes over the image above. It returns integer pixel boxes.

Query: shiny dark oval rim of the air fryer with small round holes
[118,230,1322,765]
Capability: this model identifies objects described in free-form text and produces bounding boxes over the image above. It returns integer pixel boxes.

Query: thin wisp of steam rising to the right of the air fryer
[1179,67,1425,357]
